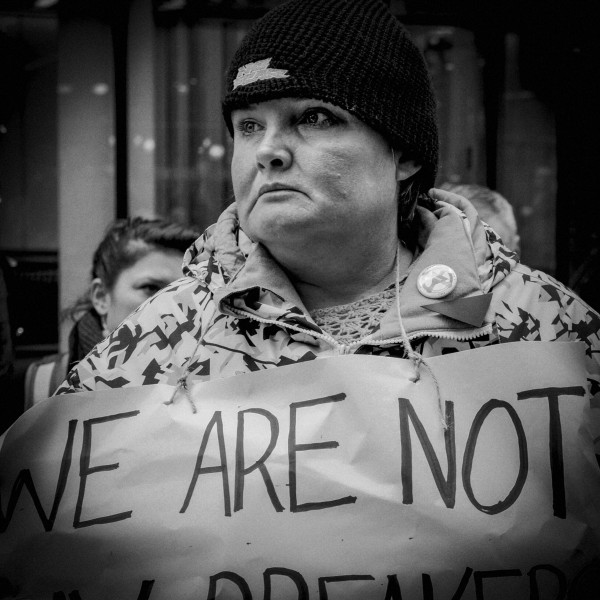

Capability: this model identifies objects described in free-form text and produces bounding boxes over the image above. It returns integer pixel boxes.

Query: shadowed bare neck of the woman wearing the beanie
[275,240,412,311]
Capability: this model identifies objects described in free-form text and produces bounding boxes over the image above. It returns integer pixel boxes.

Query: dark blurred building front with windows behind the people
[0,0,600,429]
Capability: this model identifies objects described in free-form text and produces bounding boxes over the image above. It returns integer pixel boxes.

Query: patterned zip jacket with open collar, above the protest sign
[56,201,600,404]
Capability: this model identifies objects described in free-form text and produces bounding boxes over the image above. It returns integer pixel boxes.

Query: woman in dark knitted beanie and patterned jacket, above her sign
[58,0,600,394]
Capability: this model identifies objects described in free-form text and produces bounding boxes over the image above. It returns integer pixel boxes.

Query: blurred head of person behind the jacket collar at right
[439,183,521,253]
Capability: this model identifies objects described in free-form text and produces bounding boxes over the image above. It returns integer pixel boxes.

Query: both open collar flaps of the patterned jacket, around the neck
[192,202,510,340]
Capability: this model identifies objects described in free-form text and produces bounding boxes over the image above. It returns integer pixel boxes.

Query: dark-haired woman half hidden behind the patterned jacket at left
[25,217,198,409]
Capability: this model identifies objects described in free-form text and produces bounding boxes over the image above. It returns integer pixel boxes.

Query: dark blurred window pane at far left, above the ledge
[0,12,58,251]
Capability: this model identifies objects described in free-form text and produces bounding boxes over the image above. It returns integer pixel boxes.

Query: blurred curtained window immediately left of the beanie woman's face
[155,19,252,228]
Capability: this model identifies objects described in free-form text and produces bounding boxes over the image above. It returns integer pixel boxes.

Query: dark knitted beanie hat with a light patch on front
[223,0,438,189]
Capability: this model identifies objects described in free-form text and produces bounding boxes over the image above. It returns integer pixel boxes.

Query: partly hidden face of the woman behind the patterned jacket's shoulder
[103,249,183,332]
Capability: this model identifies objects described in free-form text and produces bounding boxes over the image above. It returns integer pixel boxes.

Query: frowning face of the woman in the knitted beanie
[231,98,417,247]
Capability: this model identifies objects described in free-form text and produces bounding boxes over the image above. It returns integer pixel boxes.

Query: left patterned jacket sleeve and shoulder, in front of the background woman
[55,278,211,395]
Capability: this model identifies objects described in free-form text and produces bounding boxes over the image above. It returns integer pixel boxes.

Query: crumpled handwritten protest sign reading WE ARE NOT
[0,343,600,600]
